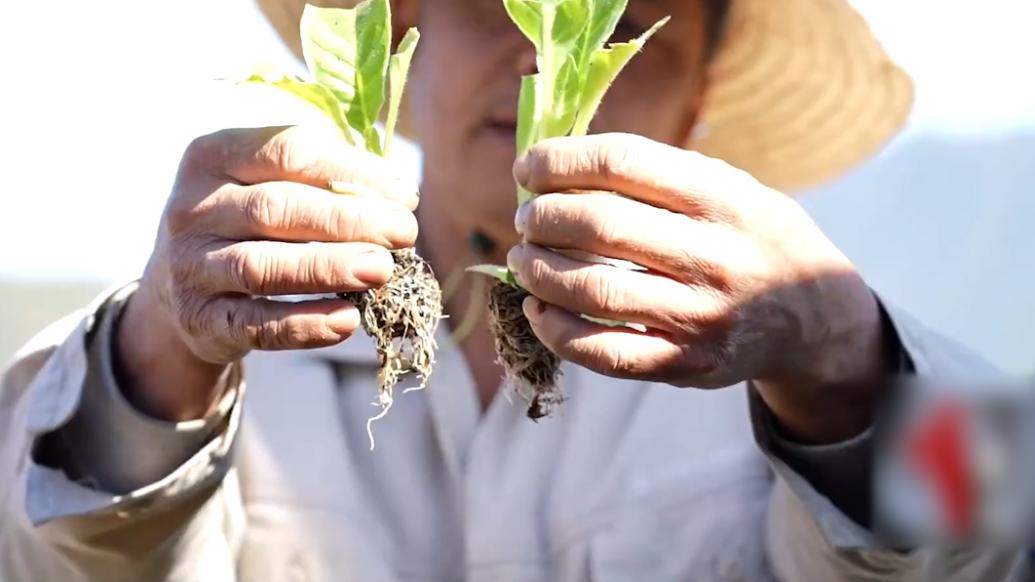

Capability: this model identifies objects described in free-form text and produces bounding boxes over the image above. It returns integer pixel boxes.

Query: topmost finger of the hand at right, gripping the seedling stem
[514,134,758,220]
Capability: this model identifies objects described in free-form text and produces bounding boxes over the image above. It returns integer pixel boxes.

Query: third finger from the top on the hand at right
[507,240,714,331]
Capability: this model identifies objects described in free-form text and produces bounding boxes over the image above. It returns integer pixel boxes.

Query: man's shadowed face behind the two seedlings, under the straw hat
[401,0,708,246]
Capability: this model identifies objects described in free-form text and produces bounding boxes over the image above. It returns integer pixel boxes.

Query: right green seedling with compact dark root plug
[471,0,669,419]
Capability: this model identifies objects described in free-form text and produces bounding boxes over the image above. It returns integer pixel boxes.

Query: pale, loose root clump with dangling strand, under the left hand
[339,244,442,434]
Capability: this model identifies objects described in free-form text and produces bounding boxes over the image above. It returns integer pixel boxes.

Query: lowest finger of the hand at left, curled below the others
[191,296,360,361]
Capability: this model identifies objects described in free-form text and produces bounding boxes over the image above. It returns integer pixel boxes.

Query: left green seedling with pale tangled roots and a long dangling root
[247,0,442,447]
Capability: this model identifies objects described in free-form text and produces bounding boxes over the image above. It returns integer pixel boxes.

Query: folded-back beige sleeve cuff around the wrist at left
[26,284,243,524]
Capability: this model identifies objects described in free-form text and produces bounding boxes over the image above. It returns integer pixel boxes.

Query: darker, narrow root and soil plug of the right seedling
[489,281,563,420]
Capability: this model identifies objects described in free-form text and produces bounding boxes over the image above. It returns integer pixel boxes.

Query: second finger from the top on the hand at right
[514,193,743,289]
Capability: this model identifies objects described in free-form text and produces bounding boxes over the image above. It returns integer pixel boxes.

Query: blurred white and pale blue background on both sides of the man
[0,0,1035,374]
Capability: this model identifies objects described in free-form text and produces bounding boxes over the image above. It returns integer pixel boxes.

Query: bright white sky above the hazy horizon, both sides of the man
[0,0,1035,282]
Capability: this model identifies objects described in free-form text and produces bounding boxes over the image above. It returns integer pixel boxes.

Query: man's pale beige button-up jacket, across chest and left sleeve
[0,286,1019,582]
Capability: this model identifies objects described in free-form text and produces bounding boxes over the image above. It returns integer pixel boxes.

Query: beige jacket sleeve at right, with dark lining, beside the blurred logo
[750,296,1035,582]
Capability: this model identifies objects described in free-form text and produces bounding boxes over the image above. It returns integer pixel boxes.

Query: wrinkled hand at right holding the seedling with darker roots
[508,135,886,439]
